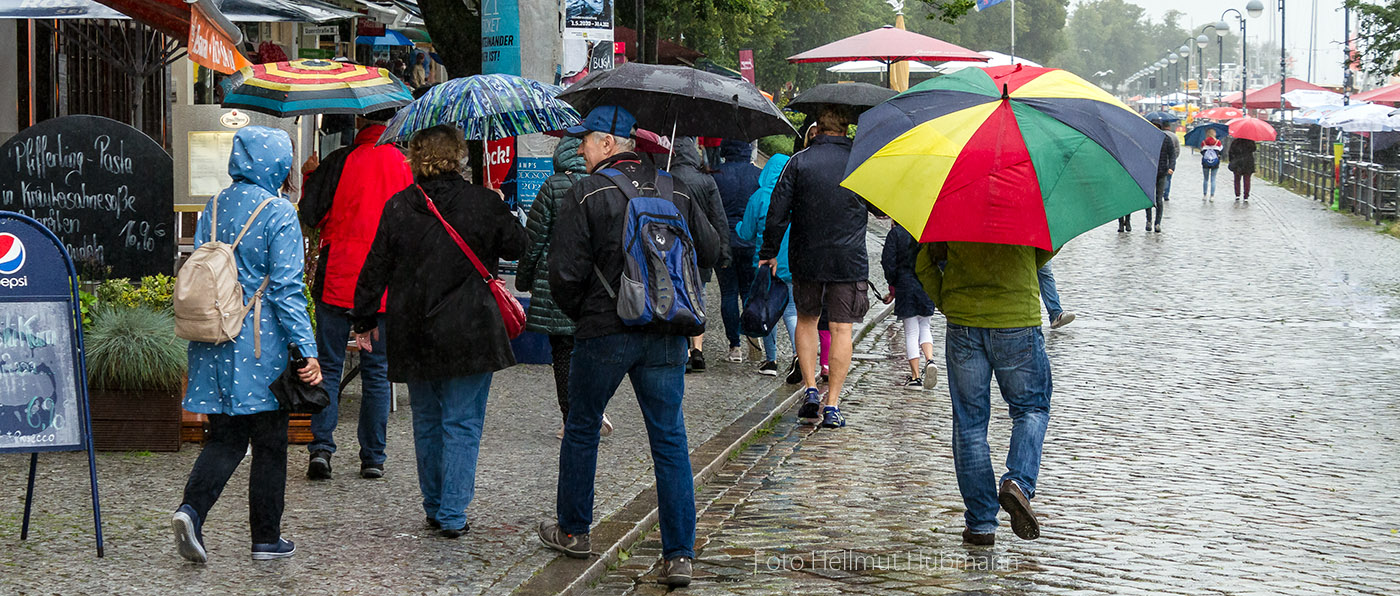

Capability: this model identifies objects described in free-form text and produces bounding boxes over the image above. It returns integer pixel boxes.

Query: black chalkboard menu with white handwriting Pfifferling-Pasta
[0,116,175,280]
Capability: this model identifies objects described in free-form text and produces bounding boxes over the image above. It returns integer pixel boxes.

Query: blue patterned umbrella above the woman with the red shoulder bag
[379,74,580,143]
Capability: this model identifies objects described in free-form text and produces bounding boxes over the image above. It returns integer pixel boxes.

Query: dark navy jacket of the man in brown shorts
[759,134,879,281]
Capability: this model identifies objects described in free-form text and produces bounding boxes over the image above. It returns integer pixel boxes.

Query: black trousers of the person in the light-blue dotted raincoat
[185,410,287,544]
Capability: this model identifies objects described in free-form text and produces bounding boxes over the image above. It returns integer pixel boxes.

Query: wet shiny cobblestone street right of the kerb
[592,164,1400,595]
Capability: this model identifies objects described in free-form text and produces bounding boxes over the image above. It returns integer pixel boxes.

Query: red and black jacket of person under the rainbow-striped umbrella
[300,125,413,312]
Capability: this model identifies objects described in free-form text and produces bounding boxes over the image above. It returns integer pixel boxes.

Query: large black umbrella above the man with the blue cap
[559,62,797,140]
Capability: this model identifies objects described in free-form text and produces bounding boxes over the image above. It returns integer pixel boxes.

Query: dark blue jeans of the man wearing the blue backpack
[556,333,696,560]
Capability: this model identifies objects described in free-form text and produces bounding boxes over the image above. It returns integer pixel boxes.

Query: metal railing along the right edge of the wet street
[1254,132,1400,224]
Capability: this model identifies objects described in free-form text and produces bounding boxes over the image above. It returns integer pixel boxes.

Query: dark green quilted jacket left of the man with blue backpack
[515,137,588,336]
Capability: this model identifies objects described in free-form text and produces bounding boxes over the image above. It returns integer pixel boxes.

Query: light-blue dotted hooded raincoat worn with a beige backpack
[185,126,316,416]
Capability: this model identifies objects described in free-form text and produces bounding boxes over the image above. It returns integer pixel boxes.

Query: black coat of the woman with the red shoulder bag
[351,172,528,382]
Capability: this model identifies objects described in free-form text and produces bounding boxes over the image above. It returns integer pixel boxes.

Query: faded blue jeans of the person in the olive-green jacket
[946,323,1051,533]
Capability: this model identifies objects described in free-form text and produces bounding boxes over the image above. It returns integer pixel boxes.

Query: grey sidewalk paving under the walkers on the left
[0,279,795,595]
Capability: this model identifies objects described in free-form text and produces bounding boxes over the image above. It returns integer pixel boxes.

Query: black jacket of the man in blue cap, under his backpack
[549,152,724,340]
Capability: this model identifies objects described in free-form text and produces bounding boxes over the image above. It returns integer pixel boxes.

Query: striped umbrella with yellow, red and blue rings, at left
[221,60,413,118]
